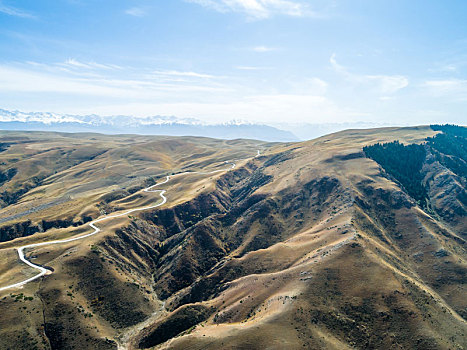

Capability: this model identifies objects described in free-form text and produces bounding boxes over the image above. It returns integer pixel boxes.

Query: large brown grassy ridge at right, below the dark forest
[134,127,466,349]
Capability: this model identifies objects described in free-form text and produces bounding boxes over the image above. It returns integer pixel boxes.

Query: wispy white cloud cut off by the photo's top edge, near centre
[185,0,316,19]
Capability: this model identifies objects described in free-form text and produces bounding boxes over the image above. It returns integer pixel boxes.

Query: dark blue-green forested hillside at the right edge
[364,125,467,232]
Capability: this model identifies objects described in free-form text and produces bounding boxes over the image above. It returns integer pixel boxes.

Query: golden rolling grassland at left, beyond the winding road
[0,132,261,241]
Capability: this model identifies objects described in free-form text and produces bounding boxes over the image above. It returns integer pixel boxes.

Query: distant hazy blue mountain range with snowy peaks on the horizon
[0,109,298,142]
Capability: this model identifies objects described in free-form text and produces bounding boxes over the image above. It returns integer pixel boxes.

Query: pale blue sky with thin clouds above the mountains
[0,0,467,125]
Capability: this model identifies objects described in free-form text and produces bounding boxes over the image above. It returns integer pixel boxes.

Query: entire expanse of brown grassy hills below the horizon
[0,126,467,349]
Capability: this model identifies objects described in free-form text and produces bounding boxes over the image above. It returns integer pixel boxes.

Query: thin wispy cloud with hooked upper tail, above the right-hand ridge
[329,54,409,95]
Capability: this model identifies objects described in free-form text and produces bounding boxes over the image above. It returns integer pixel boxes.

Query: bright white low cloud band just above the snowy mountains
[72,94,352,124]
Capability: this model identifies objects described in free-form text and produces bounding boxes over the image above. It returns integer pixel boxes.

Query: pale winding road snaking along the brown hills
[0,160,241,291]
